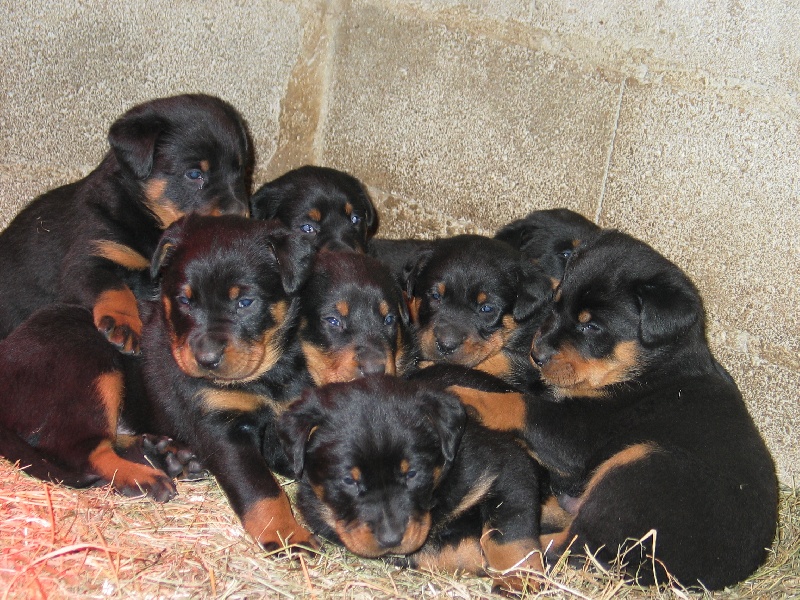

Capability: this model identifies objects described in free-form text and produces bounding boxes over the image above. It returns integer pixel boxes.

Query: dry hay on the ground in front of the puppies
[0,460,800,600]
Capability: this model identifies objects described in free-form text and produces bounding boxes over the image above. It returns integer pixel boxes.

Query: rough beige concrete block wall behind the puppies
[0,0,800,483]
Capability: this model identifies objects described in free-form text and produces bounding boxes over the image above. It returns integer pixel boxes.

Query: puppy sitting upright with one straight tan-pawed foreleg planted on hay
[126,215,313,548]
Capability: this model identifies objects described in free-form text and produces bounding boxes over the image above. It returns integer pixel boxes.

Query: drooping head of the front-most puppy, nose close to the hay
[279,376,466,557]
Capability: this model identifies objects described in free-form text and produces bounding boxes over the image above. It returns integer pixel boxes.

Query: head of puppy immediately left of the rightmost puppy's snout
[407,235,552,387]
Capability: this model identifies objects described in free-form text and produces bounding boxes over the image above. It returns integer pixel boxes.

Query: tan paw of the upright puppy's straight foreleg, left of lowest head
[242,492,316,547]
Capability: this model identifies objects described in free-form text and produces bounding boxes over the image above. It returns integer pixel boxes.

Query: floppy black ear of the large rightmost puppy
[634,272,703,346]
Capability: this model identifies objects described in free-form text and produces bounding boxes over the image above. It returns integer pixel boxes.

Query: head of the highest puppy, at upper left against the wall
[108,94,253,228]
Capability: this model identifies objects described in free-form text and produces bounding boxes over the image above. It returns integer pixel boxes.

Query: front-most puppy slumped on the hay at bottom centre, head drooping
[278,375,542,591]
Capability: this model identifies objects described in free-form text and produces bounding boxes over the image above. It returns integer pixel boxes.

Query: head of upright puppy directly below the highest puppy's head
[151,215,312,384]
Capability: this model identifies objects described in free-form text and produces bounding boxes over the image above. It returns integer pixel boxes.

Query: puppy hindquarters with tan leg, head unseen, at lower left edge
[0,304,175,502]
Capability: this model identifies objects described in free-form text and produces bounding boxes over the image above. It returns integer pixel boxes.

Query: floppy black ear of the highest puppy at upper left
[108,104,169,179]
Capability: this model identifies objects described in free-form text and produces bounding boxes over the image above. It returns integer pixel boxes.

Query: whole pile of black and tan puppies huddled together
[0,95,777,592]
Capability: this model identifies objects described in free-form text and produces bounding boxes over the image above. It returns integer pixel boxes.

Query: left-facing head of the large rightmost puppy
[531,230,704,397]
